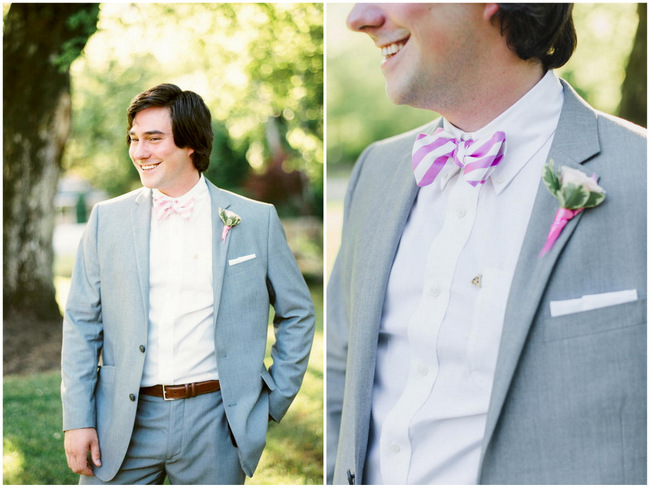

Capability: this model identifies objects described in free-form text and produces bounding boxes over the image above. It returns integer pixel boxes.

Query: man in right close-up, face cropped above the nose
[327,4,646,485]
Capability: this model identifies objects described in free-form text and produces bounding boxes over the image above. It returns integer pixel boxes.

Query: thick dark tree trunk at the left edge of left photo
[3,3,99,319]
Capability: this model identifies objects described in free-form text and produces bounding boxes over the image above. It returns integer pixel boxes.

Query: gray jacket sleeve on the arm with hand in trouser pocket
[267,206,314,422]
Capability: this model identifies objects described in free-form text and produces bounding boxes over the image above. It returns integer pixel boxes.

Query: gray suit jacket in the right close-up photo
[327,83,647,484]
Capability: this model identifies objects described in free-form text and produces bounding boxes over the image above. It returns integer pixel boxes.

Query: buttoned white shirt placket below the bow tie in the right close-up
[380,176,483,484]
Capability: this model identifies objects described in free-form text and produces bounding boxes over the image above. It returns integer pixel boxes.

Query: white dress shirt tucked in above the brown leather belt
[141,176,219,386]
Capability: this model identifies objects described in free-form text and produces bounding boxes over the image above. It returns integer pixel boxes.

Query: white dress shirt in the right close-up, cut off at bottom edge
[364,72,564,485]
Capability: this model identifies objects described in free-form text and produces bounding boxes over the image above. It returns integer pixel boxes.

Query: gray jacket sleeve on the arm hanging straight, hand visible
[61,207,103,430]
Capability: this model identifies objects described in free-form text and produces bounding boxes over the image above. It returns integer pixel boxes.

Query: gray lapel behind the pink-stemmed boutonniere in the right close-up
[482,82,600,466]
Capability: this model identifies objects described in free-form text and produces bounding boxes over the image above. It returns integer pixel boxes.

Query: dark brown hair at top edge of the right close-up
[492,3,578,70]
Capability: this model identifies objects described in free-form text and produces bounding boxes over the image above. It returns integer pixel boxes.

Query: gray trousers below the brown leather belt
[79,391,245,485]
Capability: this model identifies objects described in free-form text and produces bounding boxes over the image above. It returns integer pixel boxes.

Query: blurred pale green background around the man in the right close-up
[326,3,647,275]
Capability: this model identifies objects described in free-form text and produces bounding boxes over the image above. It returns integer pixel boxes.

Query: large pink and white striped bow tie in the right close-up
[413,127,506,186]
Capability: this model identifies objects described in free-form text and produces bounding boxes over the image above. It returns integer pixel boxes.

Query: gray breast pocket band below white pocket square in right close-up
[543,298,647,342]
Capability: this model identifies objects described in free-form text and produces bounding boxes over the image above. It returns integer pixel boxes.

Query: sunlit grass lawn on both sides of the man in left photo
[3,285,323,485]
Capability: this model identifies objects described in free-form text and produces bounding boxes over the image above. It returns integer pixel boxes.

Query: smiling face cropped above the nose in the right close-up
[347,3,486,111]
